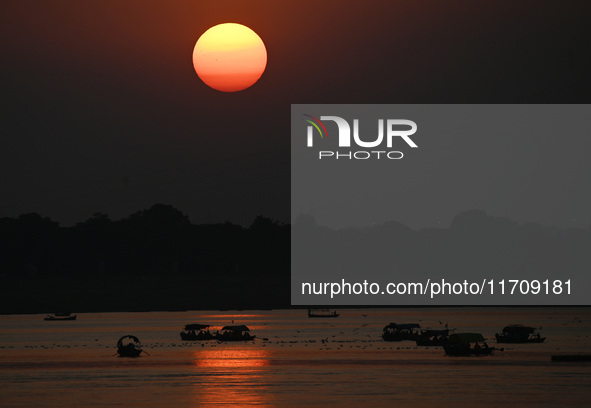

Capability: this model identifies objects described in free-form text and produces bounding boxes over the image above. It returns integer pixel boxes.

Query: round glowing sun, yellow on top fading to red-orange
[193,23,267,92]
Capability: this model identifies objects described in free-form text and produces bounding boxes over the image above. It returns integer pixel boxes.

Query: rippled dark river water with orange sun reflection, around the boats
[0,307,591,408]
